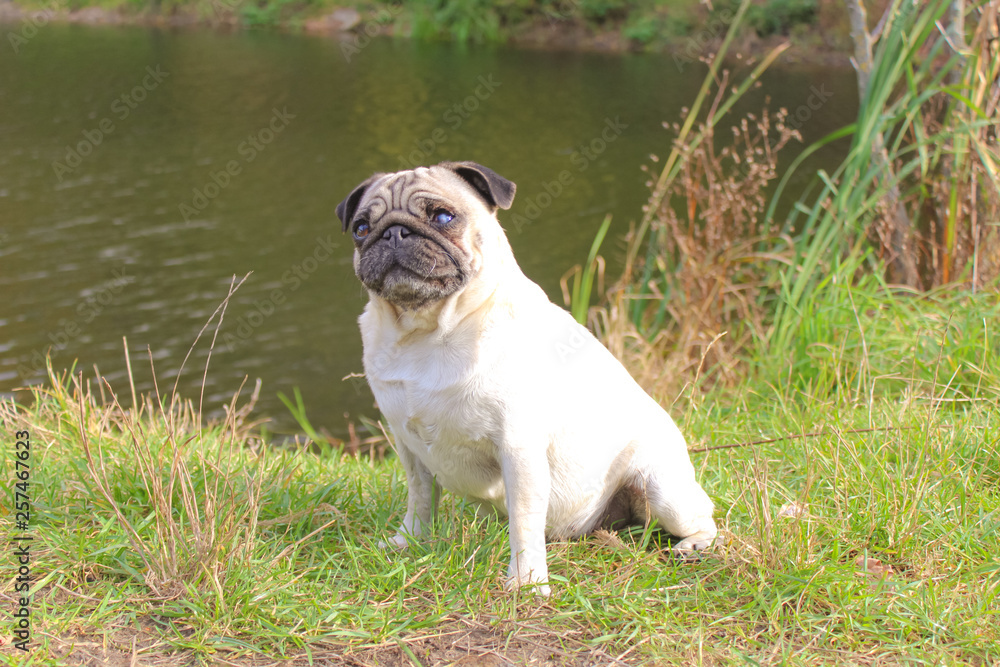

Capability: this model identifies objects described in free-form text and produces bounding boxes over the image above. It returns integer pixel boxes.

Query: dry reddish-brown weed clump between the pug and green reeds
[590,98,800,396]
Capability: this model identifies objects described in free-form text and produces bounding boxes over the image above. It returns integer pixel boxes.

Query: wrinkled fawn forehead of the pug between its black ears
[358,167,477,218]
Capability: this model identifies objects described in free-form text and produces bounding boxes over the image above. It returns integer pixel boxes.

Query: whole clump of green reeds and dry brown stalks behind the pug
[589,0,1000,404]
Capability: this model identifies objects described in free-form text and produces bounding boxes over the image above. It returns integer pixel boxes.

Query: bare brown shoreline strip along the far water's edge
[0,0,850,67]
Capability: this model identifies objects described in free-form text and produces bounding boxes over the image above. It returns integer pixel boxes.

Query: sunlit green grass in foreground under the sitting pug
[0,306,1000,665]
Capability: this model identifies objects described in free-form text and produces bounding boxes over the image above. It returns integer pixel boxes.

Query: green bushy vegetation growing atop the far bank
[5,0,836,47]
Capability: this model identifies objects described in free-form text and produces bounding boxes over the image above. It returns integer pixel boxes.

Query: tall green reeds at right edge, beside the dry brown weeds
[768,0,1000,346]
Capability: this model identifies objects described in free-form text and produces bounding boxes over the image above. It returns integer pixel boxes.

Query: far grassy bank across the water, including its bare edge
[0,0,850,57]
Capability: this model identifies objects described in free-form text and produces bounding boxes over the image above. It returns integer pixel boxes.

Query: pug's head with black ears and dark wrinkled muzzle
[337,162,515,310]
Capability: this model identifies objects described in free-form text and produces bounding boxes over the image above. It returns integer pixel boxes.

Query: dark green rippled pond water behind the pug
[0,25,857,433]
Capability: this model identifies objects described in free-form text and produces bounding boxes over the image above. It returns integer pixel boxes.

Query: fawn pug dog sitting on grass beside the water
[337,162,716,595]
